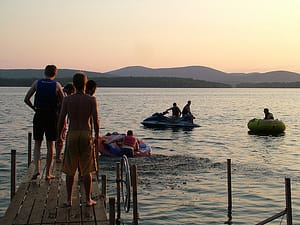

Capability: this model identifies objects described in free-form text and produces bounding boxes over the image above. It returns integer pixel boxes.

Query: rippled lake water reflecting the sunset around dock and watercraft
[0,87,300,225]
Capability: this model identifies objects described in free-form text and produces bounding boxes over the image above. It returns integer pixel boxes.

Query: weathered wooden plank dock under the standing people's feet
[0,160,108,225]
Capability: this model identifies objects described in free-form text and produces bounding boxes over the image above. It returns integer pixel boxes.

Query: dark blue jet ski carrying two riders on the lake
[141,112,200,128]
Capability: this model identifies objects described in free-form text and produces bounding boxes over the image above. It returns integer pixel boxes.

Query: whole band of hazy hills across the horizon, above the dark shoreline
[0,66,300,87]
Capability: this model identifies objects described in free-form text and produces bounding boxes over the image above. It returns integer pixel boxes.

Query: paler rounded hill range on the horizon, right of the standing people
[108,66,300,85]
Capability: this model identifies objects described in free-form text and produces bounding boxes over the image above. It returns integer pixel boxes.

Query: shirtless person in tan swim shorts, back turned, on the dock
[58,73,99,207]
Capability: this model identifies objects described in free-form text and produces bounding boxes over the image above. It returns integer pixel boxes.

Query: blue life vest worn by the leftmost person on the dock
[34,79,58,111]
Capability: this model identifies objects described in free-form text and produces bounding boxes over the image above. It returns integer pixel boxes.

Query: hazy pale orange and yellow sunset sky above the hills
[0,0,300,73]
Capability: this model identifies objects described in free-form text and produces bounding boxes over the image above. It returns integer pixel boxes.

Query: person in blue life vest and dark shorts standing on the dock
[24,65,64,180]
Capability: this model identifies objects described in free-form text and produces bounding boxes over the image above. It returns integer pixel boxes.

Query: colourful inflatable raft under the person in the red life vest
[98,133,152,157]
